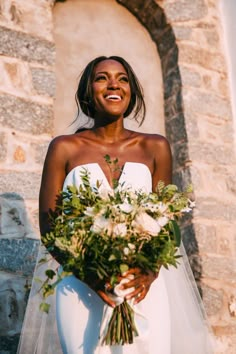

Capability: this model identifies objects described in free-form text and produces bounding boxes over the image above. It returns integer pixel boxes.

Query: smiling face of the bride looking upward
[92,59,131,118]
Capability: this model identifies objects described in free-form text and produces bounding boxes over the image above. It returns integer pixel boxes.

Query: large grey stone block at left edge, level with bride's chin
[0,95,53,135]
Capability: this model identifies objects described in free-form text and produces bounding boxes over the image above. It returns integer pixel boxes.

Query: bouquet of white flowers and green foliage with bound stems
[41,160,194,345]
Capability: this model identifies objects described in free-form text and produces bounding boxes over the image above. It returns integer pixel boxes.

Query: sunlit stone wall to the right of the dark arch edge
[158,0,236,353]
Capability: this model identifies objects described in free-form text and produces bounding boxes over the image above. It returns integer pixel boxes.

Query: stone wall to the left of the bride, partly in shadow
[0,0,55,354]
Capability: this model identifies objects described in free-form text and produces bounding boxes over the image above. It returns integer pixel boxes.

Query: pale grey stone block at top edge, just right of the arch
[164,0,208,22]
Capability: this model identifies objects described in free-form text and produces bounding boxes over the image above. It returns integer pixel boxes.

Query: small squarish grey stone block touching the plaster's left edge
[31,68,56,97]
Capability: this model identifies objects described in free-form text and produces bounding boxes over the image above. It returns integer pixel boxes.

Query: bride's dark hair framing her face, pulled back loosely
[75,56,146,126]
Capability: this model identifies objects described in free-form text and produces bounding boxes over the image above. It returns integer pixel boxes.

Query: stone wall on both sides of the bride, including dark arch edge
[0,0,236,354]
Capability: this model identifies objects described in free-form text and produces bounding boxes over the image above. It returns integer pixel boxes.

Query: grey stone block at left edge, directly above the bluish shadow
[0,171,41,199]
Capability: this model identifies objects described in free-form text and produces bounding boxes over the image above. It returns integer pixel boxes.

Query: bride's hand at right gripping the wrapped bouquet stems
[118,268,158,304]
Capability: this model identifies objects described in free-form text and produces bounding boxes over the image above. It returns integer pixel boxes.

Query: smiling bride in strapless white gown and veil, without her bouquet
[18,56,212,354]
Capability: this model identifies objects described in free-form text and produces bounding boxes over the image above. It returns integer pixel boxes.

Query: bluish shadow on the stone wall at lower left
[0,193,39,354]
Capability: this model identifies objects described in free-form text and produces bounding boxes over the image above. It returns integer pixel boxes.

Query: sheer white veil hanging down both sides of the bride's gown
[17,245,214,354]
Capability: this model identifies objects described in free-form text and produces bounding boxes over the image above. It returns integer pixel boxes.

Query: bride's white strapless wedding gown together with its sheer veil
[18,162,213,354]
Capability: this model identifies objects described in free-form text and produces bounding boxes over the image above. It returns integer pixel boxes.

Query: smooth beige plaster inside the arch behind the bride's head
[53,0,165,135]
